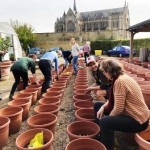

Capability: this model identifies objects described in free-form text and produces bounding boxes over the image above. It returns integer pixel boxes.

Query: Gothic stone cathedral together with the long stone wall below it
[36,0,130,50]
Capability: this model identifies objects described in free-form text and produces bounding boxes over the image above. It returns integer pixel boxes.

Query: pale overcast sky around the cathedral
[0,0,150,38]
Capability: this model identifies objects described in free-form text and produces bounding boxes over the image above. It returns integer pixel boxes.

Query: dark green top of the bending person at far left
[11,57,35,74]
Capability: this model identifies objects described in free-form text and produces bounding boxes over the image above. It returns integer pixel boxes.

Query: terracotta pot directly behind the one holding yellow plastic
[27,114,57,134]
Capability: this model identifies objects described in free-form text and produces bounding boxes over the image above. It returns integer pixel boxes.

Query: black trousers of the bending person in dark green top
[10,70,28,95]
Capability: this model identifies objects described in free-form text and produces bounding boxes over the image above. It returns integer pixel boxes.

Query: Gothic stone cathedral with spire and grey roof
[55,0,130,39]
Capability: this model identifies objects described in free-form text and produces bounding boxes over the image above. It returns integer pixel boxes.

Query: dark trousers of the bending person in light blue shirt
[39,59,52,93]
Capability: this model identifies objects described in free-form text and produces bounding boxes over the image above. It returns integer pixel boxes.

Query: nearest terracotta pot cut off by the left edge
[0,116,10,149]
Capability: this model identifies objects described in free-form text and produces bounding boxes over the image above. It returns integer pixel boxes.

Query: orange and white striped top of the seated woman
[110,74,149,124]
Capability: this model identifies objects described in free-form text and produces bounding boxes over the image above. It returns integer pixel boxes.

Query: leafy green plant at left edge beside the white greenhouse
[0,37,11,51]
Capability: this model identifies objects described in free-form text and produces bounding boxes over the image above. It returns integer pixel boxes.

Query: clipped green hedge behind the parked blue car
[91,39,150,54]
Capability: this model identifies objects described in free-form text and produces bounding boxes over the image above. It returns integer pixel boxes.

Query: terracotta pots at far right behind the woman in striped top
[120,58,150,150]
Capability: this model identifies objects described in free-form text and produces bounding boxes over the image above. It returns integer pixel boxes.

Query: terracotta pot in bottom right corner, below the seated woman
[135,124,150,150]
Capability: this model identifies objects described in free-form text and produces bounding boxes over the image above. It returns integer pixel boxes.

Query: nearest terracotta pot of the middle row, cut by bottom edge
[65,138,107,150]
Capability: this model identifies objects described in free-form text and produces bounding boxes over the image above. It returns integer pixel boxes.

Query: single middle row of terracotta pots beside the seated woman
[65,61,106,150]
